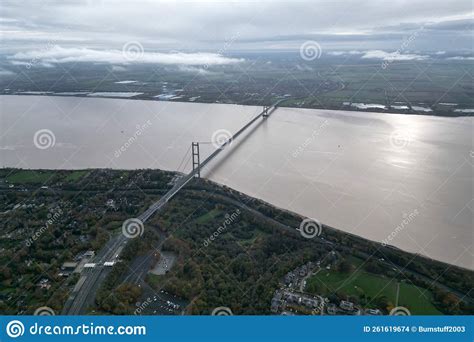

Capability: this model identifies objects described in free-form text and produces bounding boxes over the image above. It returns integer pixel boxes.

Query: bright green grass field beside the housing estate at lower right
[307,269,442,315]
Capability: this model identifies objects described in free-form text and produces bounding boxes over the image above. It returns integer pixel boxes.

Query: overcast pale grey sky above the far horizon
[0,0,474,65]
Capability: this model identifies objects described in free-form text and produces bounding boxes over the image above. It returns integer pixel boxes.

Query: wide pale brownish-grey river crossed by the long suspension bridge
[0,96,474,269]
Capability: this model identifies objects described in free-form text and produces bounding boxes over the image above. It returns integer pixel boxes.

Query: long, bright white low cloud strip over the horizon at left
[8,45,244,65]
